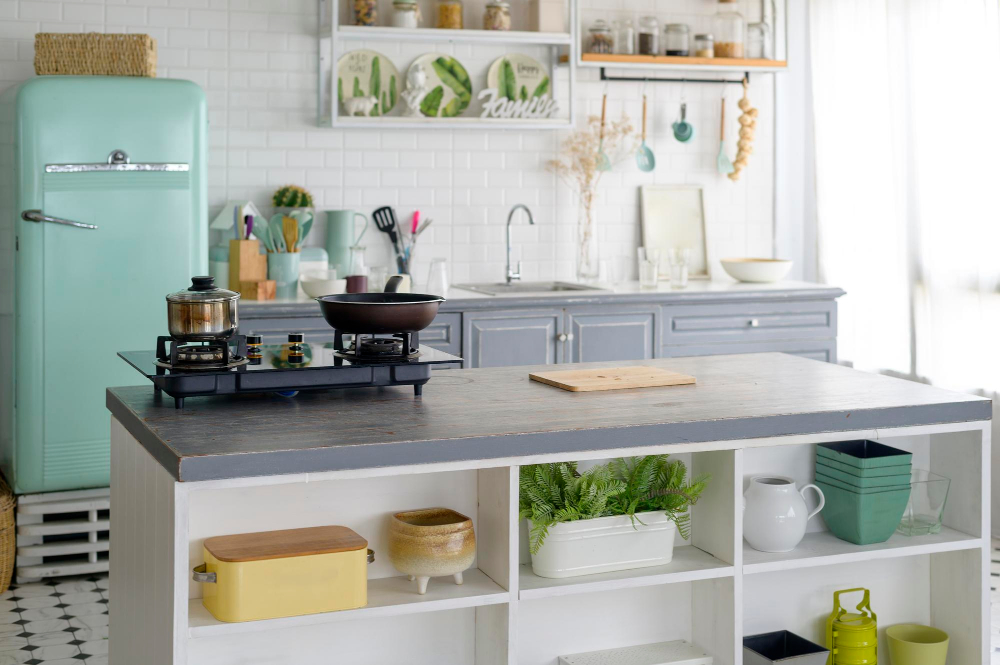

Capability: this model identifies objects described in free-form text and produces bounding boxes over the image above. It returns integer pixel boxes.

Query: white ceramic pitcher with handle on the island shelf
[743,476,826,552]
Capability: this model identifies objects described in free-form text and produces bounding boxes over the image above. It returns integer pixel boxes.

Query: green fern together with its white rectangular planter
[520,455,709,578]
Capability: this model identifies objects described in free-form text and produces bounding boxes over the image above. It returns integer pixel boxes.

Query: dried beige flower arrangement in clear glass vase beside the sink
[546,114,638,280]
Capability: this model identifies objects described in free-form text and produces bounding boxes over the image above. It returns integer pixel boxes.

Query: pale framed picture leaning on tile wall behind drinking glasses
[640,185,711,279]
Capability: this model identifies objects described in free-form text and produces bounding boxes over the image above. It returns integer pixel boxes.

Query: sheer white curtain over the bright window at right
[810,0,1000,392]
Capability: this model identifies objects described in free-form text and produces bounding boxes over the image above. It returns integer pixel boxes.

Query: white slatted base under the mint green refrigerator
[16,487,111,583]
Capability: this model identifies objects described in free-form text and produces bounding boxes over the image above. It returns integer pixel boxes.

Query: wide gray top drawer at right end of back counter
[662,301,837,346]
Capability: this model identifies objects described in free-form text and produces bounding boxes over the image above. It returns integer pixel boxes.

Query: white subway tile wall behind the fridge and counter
[0,0,775,283]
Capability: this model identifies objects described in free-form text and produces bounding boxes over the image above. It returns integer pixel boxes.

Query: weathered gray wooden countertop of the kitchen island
[107,353,991,481]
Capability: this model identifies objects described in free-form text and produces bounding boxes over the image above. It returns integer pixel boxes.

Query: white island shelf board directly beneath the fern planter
[518,546,733,600]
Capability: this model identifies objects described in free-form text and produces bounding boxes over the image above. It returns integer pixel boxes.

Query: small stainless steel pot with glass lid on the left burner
[167,277,240,342]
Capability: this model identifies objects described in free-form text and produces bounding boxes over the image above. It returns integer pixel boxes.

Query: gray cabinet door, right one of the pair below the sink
[566,307,659,363]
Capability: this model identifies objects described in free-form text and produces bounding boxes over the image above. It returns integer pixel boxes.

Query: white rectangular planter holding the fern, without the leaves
[528,511,677,578]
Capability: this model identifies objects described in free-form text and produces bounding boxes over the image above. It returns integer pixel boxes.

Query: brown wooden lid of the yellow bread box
[205,526,368,562]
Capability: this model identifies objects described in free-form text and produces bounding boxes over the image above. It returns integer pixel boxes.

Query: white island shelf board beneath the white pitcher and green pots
[743,527,983,575]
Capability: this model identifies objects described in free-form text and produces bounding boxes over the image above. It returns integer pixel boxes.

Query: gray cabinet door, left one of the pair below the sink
[462,309,564,367]
